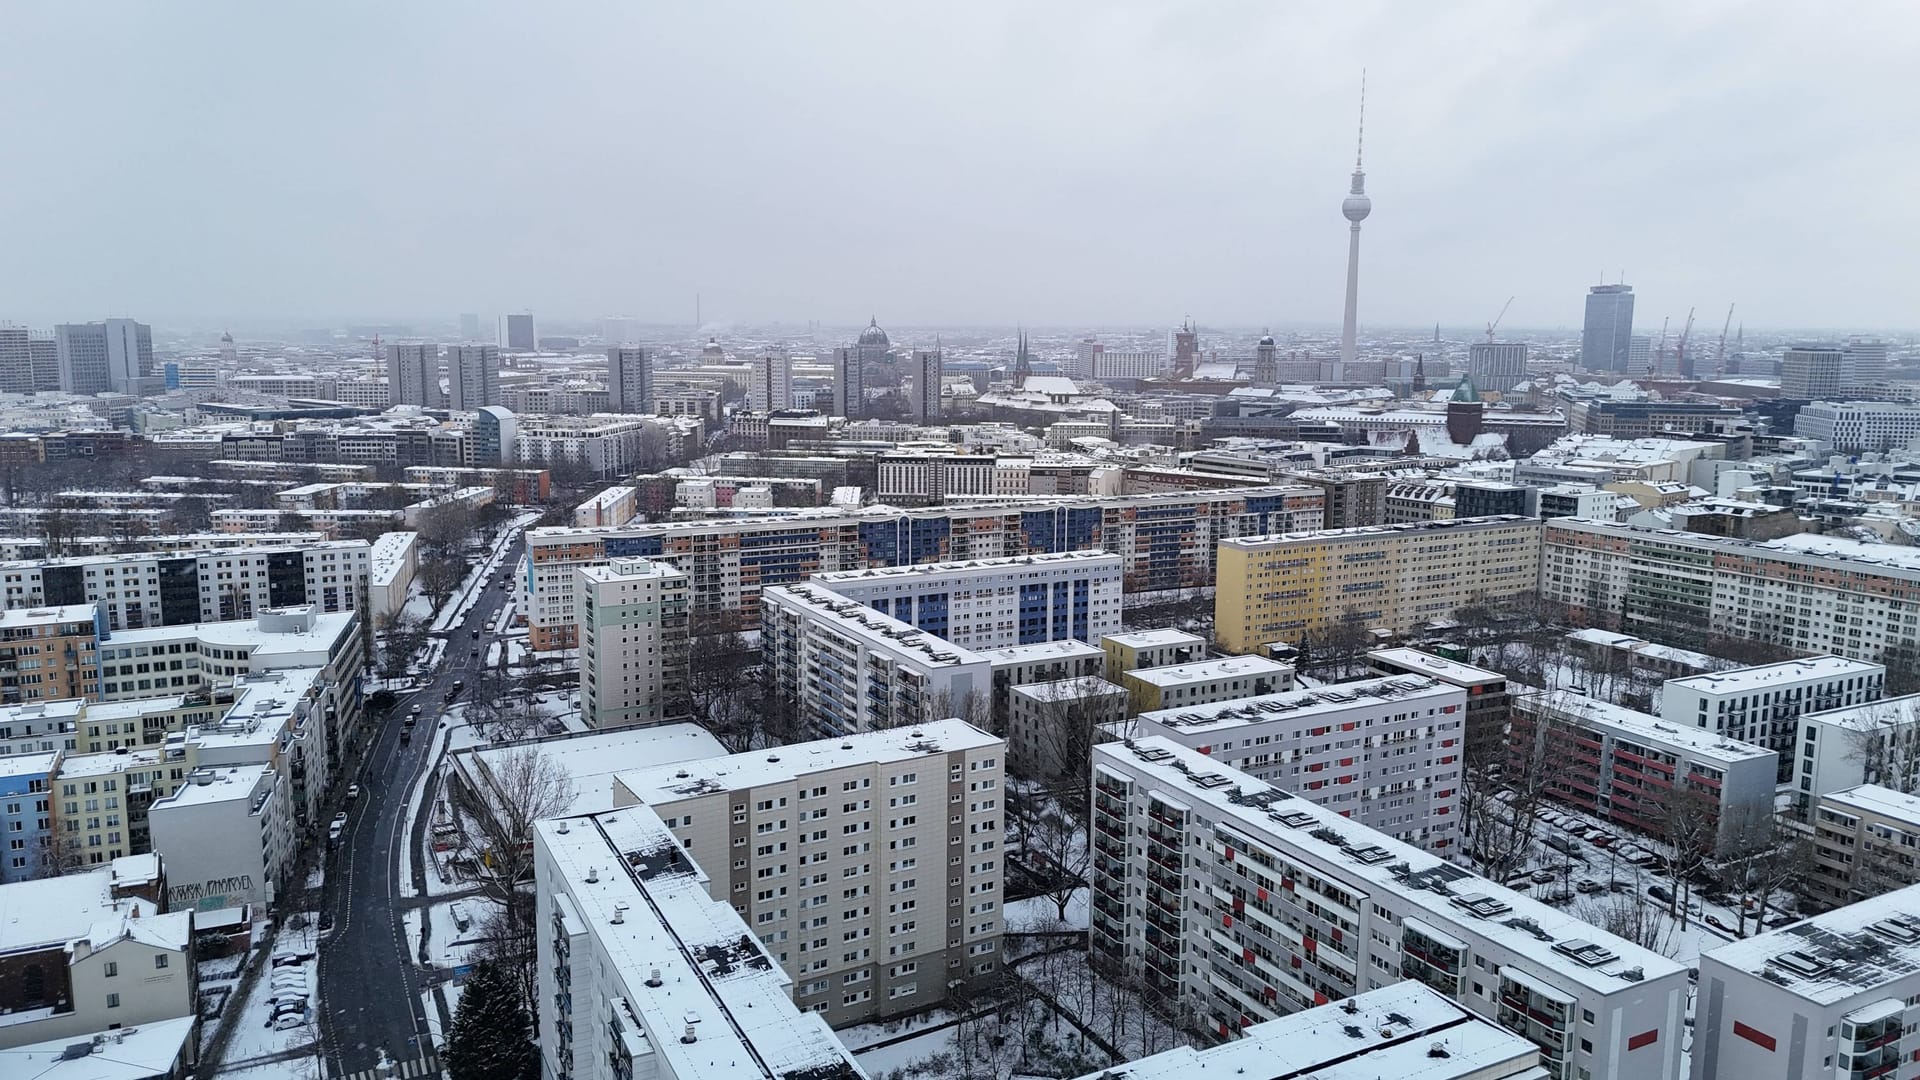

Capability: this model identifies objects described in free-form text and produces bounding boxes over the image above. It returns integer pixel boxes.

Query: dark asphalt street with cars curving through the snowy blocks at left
[321,532,524,1076]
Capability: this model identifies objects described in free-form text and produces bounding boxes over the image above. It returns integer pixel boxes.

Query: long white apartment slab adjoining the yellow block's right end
[1540,519,1920,663]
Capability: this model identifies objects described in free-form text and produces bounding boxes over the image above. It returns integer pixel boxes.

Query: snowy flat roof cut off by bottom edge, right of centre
[1083,980,1540,1080]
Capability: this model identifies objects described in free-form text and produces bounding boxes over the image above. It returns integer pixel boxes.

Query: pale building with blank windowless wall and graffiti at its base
[146,763,300,913]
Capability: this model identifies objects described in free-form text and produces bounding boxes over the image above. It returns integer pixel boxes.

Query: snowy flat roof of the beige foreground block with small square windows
[616,719,1000,805]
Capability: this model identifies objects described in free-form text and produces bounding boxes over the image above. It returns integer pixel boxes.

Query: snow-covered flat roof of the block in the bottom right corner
[1701,886,1920,1005]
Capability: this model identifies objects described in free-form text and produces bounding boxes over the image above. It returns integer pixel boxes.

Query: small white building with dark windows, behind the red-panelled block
[1661,655,1887,784]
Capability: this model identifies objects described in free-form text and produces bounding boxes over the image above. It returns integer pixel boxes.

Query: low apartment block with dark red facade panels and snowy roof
[1511,688,1780,855]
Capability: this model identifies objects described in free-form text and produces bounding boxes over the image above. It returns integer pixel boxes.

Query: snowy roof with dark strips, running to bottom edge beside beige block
[534,807,860,1080]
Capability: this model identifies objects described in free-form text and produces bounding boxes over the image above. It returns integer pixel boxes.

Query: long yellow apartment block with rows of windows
[1213,517,1540,653]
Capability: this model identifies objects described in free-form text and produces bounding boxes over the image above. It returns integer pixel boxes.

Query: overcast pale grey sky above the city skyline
[0,0,1920,327]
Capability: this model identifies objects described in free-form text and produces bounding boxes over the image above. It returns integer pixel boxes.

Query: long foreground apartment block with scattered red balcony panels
[1091,738,1688,1080]
